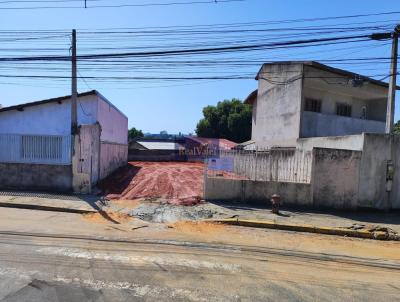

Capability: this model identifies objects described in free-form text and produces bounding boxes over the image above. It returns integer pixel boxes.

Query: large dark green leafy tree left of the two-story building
[196,99,252,143]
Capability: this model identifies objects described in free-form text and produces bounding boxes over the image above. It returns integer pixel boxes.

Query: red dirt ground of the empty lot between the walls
[99,162,204,205]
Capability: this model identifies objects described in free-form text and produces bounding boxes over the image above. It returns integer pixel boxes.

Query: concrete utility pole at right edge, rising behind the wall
[385,24,400,134]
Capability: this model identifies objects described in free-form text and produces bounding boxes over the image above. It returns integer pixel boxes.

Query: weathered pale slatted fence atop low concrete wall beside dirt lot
[206,149,312,183]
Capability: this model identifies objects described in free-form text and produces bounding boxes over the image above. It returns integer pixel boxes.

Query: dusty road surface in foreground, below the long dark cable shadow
[0,232,400,302]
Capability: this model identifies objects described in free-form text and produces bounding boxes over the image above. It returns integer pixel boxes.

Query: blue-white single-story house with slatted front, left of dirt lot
[0,90,128,191]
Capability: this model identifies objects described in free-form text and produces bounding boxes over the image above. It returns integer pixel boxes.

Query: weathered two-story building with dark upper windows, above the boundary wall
[245,61,388,148]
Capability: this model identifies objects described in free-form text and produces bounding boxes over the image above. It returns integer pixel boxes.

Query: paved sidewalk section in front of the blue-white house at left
[0,191,101,213]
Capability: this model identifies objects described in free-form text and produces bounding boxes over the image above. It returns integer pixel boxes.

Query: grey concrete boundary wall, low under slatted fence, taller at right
[205,133,400,209]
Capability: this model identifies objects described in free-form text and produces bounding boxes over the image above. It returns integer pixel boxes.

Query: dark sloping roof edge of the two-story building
[256,61,400,90]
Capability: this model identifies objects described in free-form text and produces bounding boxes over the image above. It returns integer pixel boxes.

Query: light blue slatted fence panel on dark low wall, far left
[0,134,71,165]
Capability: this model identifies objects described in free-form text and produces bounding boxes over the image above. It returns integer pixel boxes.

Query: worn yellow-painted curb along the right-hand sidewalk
[208,218,400,241]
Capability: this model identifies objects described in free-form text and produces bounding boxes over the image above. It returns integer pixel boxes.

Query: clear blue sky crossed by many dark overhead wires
[0,0,400,133]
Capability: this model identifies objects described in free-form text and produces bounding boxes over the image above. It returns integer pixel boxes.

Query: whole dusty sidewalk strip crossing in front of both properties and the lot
[0,191,400,238]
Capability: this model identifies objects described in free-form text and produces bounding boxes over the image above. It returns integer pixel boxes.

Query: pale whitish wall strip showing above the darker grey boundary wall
[296,134,364,151]
